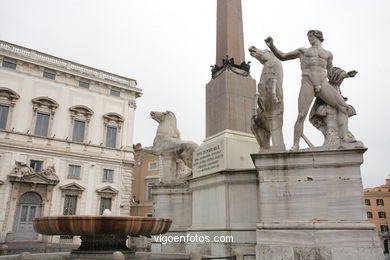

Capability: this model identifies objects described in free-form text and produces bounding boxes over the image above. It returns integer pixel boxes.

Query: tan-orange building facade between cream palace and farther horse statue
[130,143,161,217]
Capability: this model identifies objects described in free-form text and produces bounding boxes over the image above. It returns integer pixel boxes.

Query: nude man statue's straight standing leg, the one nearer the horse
[290,77,314,151]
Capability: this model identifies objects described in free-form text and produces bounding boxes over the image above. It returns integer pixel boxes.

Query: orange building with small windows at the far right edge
[364,176,390,253]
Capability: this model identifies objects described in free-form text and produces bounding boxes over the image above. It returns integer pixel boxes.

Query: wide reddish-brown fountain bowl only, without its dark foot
[33,216,172,236]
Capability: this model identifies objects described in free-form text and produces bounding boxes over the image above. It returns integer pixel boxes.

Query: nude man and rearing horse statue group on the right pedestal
[249,30,357,151]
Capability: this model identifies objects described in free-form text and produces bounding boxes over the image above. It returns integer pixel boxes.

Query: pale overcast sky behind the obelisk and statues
[0,0,390,188]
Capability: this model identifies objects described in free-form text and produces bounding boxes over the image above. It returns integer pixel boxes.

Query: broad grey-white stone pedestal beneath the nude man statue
[252,149,384,260]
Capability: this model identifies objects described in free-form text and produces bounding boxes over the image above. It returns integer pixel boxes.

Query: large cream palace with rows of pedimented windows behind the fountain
[0,41,142,243]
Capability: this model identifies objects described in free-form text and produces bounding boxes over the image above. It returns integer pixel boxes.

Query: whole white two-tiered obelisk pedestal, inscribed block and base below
[187,130,259,256]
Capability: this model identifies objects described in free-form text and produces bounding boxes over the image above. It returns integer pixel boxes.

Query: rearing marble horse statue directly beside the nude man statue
[249,46,286,151]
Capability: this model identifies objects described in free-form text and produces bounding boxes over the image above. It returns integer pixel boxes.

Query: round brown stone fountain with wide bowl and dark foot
[33,216,172,259]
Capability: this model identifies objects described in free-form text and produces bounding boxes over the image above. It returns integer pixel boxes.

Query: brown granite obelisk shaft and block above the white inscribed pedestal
[206,0,256,138]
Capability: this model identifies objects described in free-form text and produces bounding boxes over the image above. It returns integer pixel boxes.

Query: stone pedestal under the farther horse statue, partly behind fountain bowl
[152,183,192,253]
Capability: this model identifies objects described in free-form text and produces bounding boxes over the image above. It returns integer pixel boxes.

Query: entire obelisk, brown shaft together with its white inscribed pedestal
[186,0,259,259]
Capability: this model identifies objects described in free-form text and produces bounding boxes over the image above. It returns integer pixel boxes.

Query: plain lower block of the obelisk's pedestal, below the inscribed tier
[187,169,258,256]
